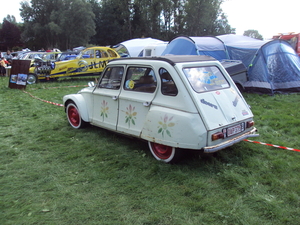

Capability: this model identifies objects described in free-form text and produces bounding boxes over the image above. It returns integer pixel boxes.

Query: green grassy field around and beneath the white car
[0,77,300,225]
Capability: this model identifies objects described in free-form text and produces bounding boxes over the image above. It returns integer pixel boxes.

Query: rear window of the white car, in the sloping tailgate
[183,66,229,92]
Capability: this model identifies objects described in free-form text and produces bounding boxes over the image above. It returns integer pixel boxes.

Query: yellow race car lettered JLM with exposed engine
[27,47,120,84]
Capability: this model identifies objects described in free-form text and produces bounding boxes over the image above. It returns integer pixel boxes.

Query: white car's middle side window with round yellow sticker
[124,67,157,93]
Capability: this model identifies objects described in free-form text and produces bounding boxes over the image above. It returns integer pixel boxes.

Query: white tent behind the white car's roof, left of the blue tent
[114,38,163,57]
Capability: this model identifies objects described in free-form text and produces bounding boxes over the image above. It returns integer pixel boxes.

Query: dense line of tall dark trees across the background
[0,0,235,50]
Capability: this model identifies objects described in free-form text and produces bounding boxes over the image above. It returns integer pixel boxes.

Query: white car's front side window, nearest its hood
[98,67,124,90]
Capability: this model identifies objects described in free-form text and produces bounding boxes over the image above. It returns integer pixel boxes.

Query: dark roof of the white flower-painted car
[110,55,217,65]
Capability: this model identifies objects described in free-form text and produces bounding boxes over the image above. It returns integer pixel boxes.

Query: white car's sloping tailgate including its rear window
[183,66,253,130]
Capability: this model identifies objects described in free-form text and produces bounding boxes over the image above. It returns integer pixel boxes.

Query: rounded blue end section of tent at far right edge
[244,39,300,94]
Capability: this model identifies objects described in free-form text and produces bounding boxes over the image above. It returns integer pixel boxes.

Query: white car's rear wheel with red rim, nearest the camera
[148,141,182,163]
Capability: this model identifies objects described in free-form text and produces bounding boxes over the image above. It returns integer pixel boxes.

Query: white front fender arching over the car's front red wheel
[63,94,90,122]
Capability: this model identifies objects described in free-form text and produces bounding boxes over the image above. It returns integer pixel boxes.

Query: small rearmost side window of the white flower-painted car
[159,68,178,96]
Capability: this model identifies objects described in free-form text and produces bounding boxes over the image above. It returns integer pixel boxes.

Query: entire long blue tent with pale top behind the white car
[162,34,300,94]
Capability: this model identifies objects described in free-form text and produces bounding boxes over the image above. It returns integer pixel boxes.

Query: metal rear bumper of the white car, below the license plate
[203,127,259,153]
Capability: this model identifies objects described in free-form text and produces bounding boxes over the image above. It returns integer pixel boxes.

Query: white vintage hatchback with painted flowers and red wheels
[63,55,258,163]
